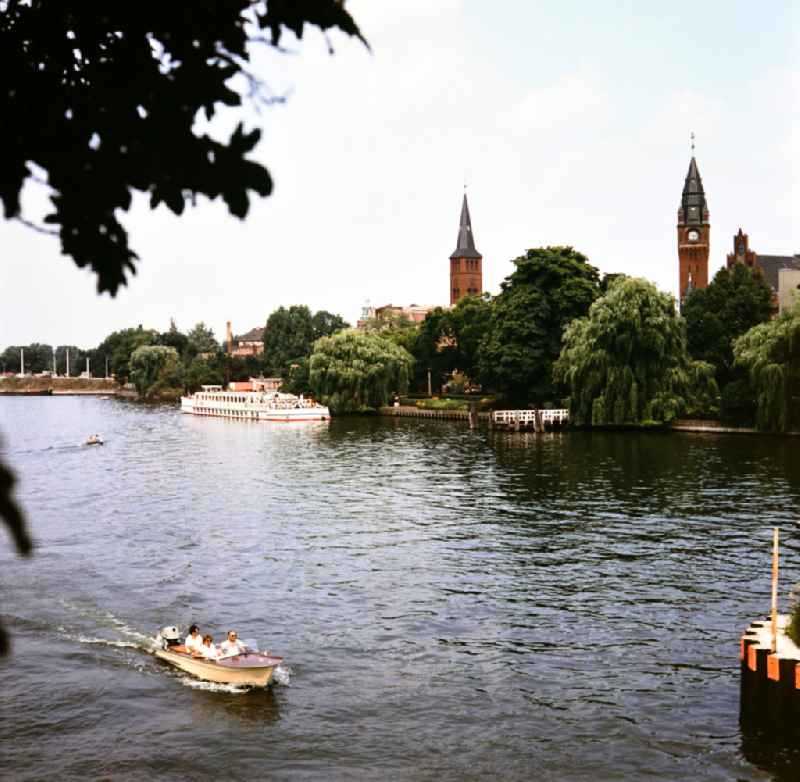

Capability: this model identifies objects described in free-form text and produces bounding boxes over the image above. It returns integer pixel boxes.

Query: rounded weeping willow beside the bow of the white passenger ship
[310,329,414,413]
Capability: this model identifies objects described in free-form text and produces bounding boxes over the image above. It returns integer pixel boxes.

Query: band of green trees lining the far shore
[0,247,800,433]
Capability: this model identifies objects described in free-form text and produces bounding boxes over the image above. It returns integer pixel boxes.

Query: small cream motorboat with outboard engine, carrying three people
[153,627,283,687]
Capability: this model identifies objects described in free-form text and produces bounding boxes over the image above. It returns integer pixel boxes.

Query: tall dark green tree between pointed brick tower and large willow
[477,247,600,404]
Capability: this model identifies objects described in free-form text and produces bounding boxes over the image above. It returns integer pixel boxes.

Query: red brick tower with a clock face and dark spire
[678,154,710,302]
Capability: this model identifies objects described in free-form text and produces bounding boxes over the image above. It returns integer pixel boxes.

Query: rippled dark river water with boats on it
[0,397,800,780]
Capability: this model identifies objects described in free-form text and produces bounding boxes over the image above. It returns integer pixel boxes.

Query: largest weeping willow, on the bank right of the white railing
[553,277,718,426]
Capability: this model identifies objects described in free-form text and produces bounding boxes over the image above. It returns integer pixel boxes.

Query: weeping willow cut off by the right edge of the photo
[733,302,800,432]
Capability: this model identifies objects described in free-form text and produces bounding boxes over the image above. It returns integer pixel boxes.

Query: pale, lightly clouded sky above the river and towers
[0,0,800,350]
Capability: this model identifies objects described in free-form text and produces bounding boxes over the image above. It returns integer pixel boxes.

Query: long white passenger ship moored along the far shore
[181,379,331,422]
